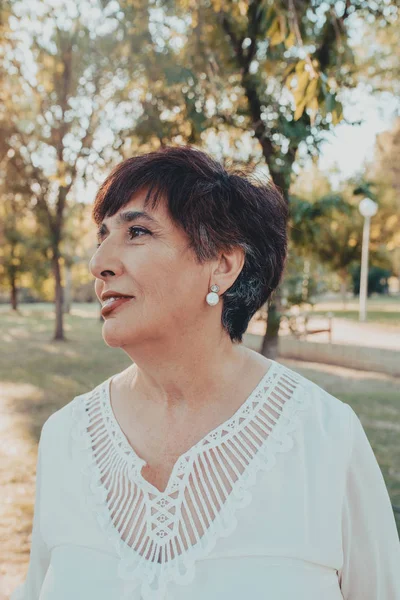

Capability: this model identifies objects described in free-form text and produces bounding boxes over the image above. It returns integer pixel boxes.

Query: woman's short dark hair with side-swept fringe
[92,145,288,342]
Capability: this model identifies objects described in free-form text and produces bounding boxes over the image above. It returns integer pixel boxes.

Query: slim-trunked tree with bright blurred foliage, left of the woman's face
[1,1,143,340]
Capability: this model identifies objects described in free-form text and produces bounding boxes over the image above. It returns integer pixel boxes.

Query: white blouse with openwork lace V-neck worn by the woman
[11,361,400,600]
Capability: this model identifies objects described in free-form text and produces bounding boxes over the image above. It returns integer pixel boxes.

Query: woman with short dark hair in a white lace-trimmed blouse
[13,147,400,600]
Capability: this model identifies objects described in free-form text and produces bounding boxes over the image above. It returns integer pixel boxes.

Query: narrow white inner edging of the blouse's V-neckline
[101,358,281,497]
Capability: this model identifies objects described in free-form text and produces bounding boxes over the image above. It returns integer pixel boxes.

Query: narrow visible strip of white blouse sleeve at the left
[10,425,50,600]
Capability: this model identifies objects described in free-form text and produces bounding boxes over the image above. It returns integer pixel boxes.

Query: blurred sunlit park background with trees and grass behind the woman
[0,0,400,595]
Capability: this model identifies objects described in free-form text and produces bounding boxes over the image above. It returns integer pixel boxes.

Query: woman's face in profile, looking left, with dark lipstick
[89,191,211,347]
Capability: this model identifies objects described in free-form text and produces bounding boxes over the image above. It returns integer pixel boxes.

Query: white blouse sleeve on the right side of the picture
[338,405,400,600]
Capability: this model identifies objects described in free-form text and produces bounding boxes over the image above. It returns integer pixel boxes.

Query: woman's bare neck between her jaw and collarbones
[120,332,251,414]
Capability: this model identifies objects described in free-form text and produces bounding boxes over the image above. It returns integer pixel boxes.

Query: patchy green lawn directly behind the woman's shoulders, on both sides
[0,304,400,593]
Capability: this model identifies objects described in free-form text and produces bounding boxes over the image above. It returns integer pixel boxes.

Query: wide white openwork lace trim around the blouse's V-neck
[72,361,310,600]
